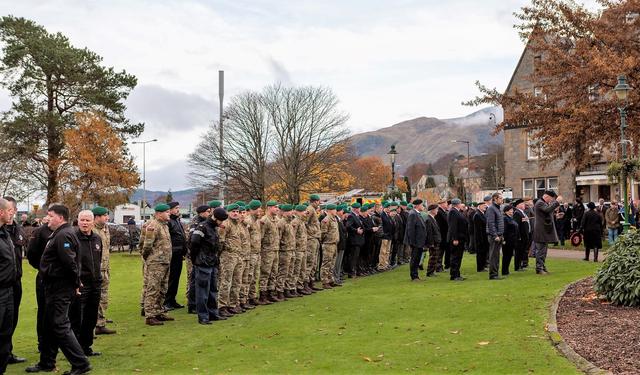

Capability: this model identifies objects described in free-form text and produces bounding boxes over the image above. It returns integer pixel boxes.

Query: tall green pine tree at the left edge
[0,16,144,204]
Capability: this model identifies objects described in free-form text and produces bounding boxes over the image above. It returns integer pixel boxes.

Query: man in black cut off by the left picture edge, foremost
[0,199,17,374]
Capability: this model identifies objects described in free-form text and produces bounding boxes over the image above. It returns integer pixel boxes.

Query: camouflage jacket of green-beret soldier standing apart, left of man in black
[140,218,171,264]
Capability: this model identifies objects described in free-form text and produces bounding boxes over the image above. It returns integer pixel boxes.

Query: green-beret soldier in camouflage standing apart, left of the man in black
[140,204,174,326]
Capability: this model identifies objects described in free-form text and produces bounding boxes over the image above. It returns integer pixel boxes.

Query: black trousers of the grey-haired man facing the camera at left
[69,282,101,354]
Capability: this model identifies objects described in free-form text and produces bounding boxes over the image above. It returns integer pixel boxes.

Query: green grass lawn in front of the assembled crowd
[8,254,598,374]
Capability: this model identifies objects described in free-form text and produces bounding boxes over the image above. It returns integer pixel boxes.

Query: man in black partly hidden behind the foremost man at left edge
[4,197,26,365]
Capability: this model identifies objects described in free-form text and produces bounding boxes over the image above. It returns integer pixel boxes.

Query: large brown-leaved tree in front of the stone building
[467,0,640,169]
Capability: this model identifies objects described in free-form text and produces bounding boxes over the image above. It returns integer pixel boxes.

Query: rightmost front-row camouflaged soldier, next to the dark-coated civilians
[320,204,340,289]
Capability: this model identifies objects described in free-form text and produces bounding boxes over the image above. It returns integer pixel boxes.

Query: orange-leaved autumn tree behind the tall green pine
[56,112,140,213]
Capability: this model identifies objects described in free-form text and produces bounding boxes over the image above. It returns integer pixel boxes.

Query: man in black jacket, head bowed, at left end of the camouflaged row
[190,207,228,324]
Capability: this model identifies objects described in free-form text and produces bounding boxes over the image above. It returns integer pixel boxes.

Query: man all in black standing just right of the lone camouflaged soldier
[164,202,187,311]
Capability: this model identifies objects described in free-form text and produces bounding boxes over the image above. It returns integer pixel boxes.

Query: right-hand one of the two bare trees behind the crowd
[262,85,349,203]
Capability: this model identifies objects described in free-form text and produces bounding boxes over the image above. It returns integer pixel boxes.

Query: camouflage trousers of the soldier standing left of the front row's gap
[143,262,169,318]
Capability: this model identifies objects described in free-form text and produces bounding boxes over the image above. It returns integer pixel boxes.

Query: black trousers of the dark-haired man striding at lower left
[40,280,89,369]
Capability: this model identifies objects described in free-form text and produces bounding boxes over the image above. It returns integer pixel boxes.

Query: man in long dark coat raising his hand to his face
[533,190,562,275]
